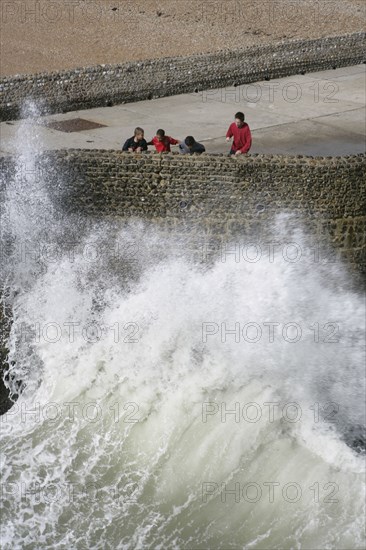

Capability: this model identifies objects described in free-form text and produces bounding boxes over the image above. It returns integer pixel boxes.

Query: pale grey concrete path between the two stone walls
[0,65,366,156]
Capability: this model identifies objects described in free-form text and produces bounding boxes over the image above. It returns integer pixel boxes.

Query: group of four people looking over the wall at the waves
[122,112,252,155]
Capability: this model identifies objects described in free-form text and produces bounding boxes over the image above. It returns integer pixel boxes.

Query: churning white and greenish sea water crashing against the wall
[0,110,365,549]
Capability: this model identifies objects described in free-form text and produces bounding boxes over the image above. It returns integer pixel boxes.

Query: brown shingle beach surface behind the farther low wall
[0,0,366,76]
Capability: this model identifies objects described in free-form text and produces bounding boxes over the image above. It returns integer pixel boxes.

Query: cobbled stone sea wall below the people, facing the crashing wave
[0,149,366,272]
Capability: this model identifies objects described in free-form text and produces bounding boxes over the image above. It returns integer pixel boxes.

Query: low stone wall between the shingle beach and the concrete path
[0,32,366,120]
